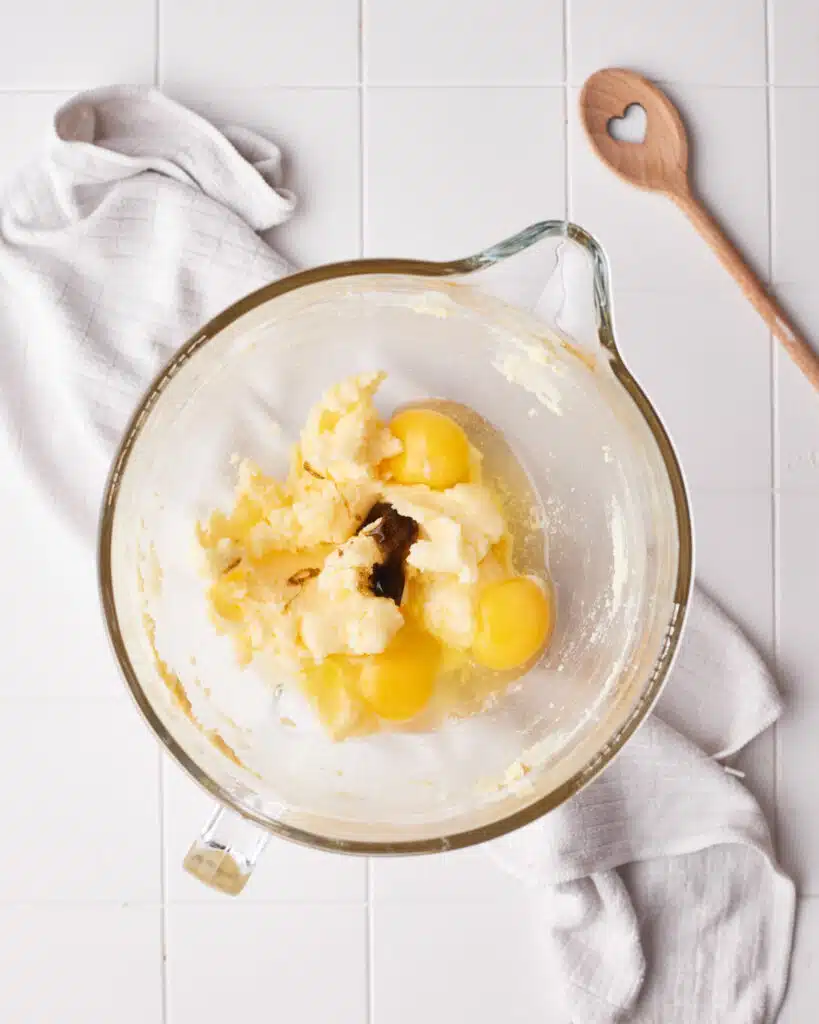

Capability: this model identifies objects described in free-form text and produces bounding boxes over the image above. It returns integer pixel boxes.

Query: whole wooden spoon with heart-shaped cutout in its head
[580,68,819,390]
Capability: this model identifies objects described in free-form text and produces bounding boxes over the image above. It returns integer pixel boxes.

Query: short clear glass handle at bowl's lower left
[182,808,270,896]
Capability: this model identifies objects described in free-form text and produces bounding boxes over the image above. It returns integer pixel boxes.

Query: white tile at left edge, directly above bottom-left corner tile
[0,697,160,901]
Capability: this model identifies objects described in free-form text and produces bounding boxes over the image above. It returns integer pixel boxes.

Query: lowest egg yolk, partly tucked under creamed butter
[358,623,441,722]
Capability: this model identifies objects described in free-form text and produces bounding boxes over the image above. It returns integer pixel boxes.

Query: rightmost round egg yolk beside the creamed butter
[472,577,554,671]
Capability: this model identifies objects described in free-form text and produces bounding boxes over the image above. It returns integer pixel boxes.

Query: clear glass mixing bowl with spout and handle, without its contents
[99,221,692,892]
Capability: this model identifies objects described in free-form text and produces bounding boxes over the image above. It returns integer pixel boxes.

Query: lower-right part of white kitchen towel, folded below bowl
[489,591,795,1024]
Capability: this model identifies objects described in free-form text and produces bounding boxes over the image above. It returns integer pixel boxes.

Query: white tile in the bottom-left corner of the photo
[0,903,162,1024]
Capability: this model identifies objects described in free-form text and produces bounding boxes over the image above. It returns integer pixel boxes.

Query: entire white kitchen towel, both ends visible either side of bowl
[0,88,794,1024]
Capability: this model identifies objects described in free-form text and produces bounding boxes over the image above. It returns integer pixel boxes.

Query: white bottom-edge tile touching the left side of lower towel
[373,905,555,1024]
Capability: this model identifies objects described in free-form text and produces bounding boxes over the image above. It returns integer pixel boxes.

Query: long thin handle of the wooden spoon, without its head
[671,190,819,391]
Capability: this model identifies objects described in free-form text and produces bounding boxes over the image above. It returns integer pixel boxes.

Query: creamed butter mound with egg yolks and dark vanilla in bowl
[197,373,554,739]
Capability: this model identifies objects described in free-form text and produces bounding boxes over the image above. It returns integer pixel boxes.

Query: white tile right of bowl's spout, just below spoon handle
[614,281,771,487]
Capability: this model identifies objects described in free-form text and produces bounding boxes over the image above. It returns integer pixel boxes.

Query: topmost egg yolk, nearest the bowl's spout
[387,409,470,490]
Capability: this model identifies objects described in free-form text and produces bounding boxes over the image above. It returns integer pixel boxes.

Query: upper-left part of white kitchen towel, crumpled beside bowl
[0,87,295,537]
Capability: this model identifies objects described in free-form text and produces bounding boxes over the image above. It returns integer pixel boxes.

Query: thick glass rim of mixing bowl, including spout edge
[97,220,694,855]
